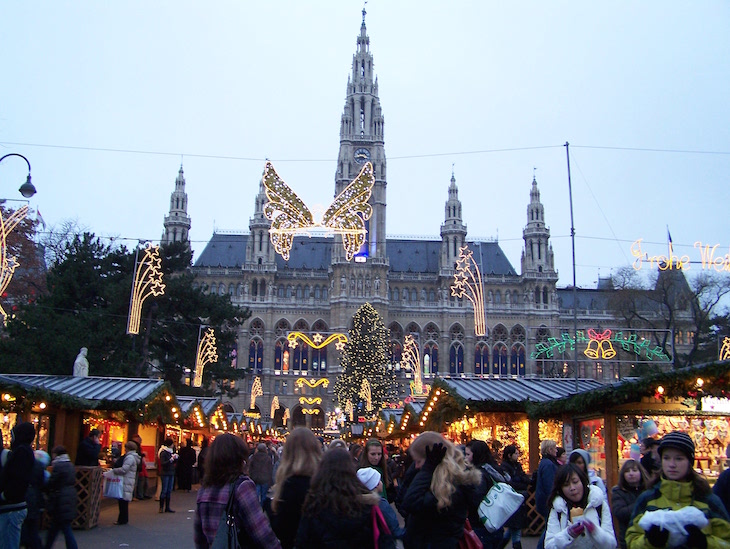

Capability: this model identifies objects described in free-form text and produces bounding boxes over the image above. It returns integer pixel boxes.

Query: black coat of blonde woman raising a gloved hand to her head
[400,467,474,549]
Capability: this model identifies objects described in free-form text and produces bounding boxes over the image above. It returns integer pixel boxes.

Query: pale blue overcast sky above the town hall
[0,0,730,288]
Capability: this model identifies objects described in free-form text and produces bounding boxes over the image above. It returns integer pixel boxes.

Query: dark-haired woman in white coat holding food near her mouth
[545,463,616,549]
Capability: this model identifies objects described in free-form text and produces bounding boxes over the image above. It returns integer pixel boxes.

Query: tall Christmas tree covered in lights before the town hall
[335,303,396,417]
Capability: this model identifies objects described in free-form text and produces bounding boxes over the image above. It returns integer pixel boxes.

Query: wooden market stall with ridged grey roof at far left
[0,374,179,529]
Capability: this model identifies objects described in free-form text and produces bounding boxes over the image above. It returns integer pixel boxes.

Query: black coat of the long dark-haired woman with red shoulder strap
[296,494,380,549]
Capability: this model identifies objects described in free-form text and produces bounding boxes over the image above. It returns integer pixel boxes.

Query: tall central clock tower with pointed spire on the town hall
[332,9,387,263]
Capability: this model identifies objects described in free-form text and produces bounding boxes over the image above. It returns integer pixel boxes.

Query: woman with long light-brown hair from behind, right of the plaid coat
[269,427,322,549]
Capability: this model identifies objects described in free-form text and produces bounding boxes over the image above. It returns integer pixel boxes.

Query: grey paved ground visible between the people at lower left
[47,490,537,549]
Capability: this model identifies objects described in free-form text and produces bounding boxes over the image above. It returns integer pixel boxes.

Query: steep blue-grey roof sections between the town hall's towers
[195,233,517,276]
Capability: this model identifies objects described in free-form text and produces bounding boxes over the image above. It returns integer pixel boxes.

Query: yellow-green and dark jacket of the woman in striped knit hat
[626,478,730,549]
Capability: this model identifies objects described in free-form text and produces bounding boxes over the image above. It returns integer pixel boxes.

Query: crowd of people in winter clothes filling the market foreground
[0,423,730,549]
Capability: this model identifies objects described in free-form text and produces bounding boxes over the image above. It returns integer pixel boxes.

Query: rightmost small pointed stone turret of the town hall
[522,175,558,310]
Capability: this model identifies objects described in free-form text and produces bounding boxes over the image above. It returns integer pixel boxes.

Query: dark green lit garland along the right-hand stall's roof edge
[526,361,730,418]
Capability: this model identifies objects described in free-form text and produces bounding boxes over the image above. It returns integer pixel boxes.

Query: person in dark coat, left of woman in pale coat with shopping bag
[46,446,77,549]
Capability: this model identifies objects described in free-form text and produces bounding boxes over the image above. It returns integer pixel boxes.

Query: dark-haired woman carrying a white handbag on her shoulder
[464,439,507,547]
